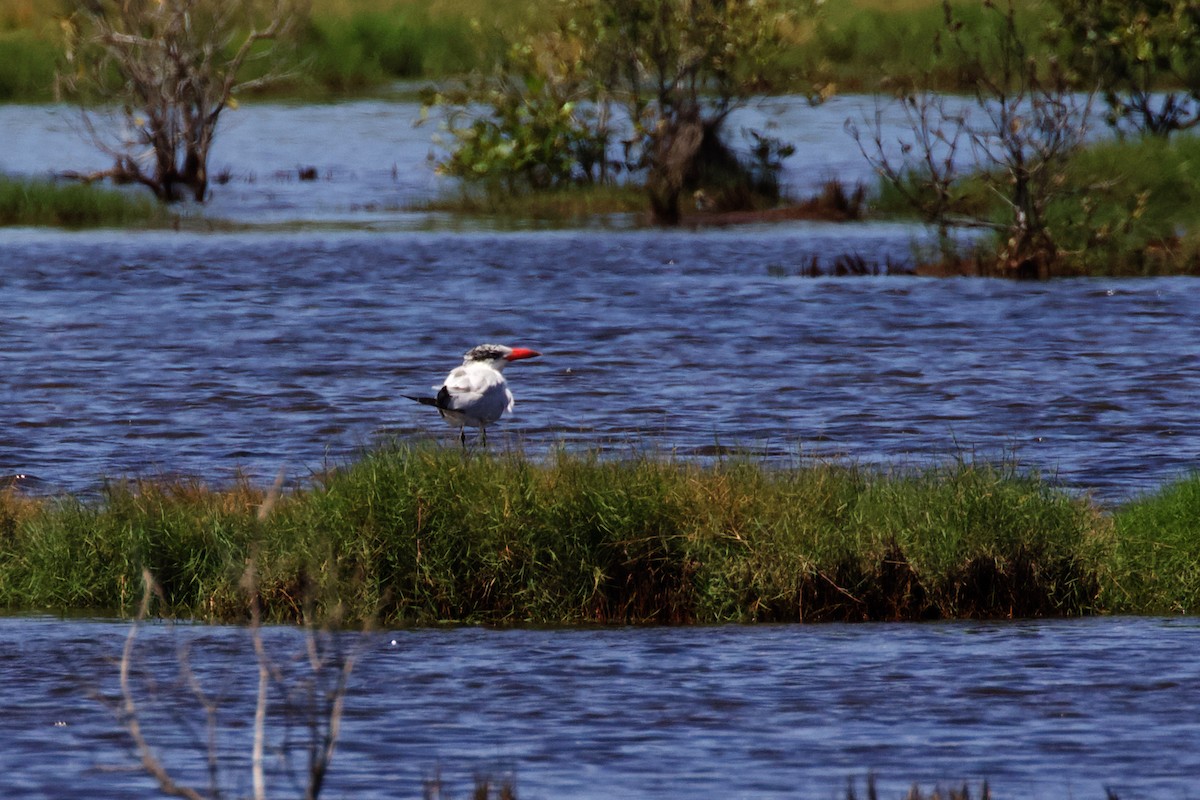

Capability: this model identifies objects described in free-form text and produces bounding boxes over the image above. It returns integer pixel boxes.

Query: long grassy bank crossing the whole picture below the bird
[0,446,1200,624]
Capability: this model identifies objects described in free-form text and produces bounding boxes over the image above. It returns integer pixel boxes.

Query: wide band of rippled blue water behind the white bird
[0,223,1200,498]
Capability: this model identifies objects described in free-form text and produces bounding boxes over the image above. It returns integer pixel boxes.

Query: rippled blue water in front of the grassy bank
[0,619,1200,800]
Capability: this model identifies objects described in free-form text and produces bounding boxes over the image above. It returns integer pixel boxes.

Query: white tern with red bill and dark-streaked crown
[404,344,541,447]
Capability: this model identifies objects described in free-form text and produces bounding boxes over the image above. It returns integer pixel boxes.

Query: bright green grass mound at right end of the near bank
[1100,475,1200,614]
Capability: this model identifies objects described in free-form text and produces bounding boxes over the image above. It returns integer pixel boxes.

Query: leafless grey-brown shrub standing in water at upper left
[60,0,300,203]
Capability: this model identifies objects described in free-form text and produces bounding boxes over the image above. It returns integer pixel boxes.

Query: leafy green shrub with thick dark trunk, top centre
[426,0,815,223]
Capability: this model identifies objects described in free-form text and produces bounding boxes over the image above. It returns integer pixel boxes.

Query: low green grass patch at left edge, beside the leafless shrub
[0,176,168,228]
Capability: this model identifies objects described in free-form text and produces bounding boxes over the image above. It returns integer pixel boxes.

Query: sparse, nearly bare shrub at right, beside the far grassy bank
[847,0,1094,277]
